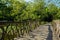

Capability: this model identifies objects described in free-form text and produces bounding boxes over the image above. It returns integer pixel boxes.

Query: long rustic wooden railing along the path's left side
[0,21,39,40]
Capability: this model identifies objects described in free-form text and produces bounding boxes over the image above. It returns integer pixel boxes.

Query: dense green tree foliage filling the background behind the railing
[0,0,60,21]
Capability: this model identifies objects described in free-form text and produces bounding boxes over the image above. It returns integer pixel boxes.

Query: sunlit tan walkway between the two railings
[15,24,57,40]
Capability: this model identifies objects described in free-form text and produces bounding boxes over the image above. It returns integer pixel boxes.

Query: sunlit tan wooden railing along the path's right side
[52,20,60,39]
